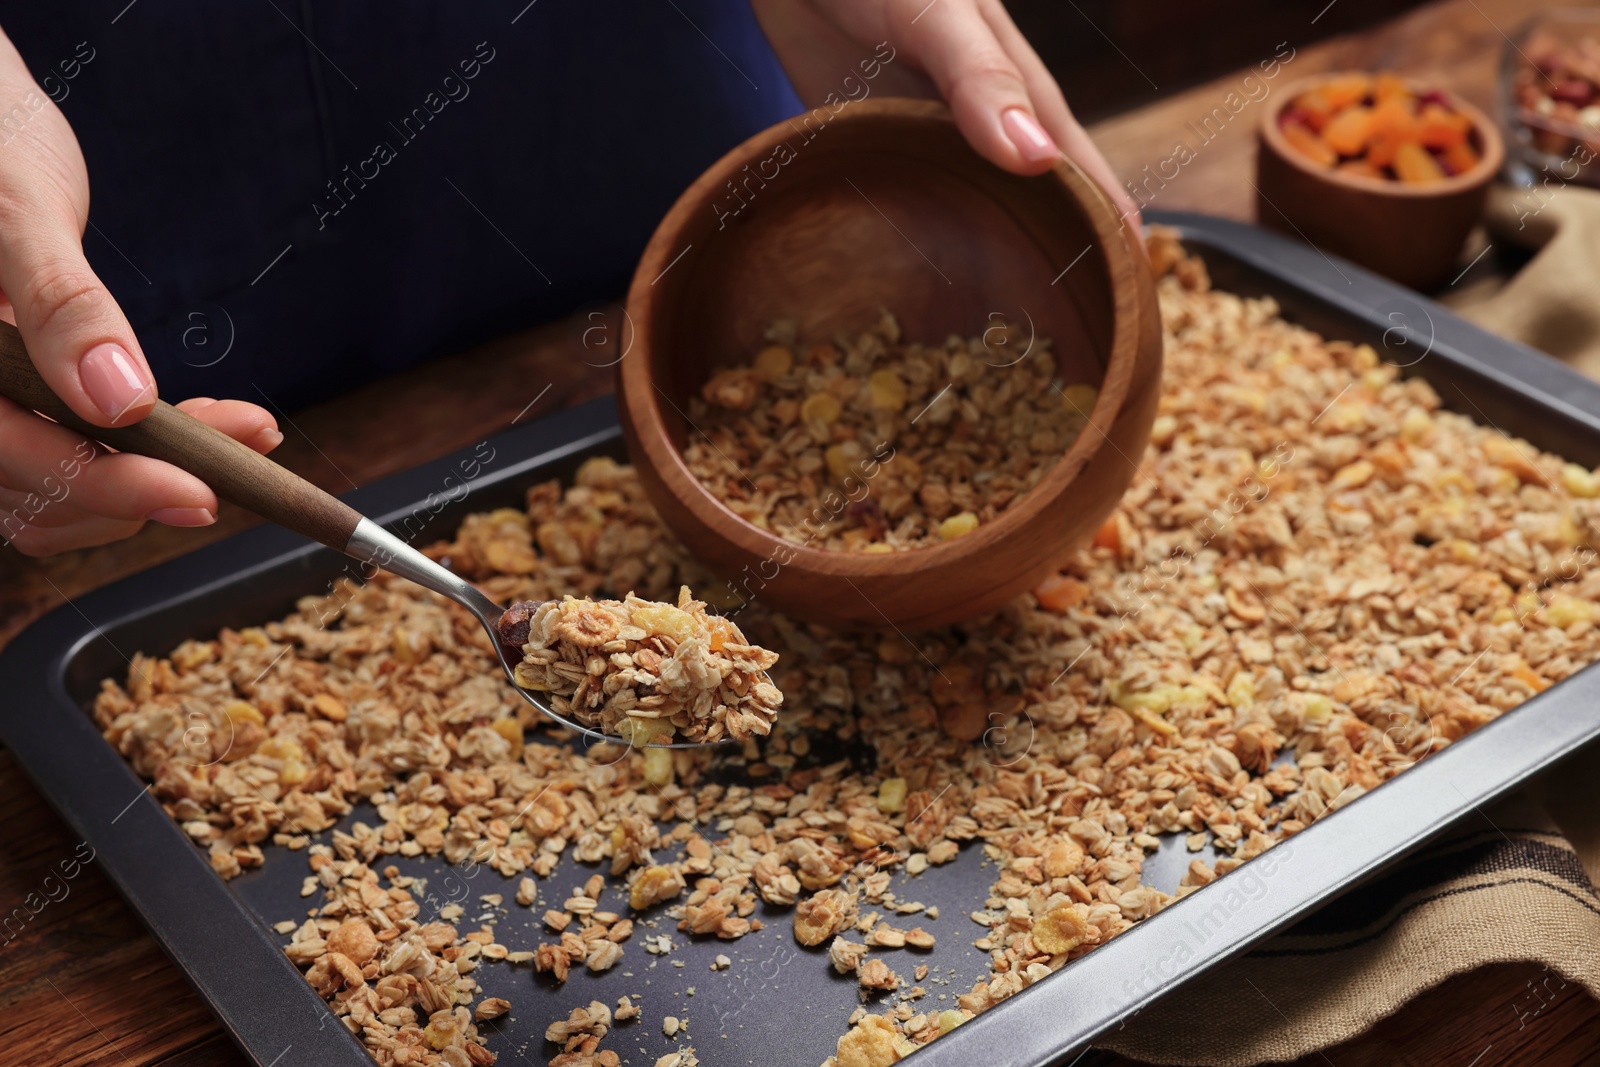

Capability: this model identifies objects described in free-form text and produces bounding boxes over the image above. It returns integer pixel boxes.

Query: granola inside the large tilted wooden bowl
[683,312,1099,552]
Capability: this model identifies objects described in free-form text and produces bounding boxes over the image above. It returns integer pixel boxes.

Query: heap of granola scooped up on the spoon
[499,585,784,745]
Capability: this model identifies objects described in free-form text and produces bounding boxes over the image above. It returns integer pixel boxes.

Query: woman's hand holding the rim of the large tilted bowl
[752,0,1139,227]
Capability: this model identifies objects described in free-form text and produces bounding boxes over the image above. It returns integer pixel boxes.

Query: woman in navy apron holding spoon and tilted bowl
[0,0,1136,555]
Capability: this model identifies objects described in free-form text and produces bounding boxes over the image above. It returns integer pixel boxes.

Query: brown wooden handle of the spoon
[0,322,362,552]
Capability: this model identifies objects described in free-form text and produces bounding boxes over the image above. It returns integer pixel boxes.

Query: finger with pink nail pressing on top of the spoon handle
[0,202,155,426]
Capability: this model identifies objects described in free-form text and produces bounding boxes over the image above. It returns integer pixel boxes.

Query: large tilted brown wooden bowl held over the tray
[618,99,1162,629]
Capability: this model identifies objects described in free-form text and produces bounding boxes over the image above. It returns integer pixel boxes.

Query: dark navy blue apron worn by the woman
[0,0,802,411]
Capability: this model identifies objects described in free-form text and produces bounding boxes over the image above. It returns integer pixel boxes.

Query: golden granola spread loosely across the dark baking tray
[94,237,1600,1067]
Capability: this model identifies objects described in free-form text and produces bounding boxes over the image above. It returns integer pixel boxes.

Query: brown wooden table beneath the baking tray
[0,0,1600,1067]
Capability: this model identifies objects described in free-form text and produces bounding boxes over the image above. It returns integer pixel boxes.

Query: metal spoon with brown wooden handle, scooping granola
[0,322,726,749]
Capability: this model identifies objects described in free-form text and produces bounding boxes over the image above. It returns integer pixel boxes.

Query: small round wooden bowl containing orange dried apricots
[1256,74,1506,290]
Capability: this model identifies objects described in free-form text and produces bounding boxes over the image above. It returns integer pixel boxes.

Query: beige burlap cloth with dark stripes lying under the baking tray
[1098,186,1600,1067]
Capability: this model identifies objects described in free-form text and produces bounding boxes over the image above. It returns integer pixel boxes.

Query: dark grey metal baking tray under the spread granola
[0,214,1600,1067]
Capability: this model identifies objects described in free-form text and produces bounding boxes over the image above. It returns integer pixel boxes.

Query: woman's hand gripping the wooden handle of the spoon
[0,34,283,555]
